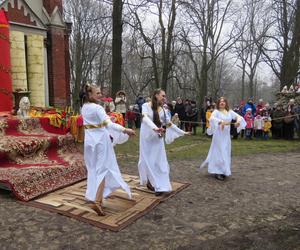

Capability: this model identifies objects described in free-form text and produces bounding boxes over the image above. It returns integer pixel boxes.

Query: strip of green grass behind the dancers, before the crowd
[116,131,300,162]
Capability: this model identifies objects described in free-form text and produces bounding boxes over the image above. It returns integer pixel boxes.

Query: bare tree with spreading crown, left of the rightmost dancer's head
[181,0,238,103]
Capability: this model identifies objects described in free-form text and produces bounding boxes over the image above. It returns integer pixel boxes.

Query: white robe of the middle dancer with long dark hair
[138,103,185,192]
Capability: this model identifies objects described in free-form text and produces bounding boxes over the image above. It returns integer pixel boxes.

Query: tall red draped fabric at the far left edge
[0,10,13,112]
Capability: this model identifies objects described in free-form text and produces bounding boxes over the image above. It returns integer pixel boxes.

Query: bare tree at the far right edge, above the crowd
[263,0,300,88]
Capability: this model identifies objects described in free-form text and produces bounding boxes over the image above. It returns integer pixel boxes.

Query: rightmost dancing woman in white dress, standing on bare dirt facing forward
[200,97,246,181]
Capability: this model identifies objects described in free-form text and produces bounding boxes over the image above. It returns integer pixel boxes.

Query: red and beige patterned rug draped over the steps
[0,118,86,201]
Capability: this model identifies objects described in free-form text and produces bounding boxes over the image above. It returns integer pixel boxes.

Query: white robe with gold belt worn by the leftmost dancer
[81,103,131,201]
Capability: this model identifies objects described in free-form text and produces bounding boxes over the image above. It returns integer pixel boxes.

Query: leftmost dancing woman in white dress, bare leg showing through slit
[81,84,135,216]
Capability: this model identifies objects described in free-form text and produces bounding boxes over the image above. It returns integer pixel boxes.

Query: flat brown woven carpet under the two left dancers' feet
[25,175,189,231]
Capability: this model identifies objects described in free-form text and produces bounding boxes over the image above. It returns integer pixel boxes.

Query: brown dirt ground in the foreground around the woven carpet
[0,152,300,250]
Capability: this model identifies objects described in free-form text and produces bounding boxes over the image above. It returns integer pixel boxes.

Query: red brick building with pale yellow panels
[0,0,71,107]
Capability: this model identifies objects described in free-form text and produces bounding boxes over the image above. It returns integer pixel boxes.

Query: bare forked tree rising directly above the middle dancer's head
[125,0,178,91]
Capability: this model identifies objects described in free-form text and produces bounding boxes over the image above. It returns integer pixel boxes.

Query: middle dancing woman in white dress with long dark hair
[138,89,189,196]
